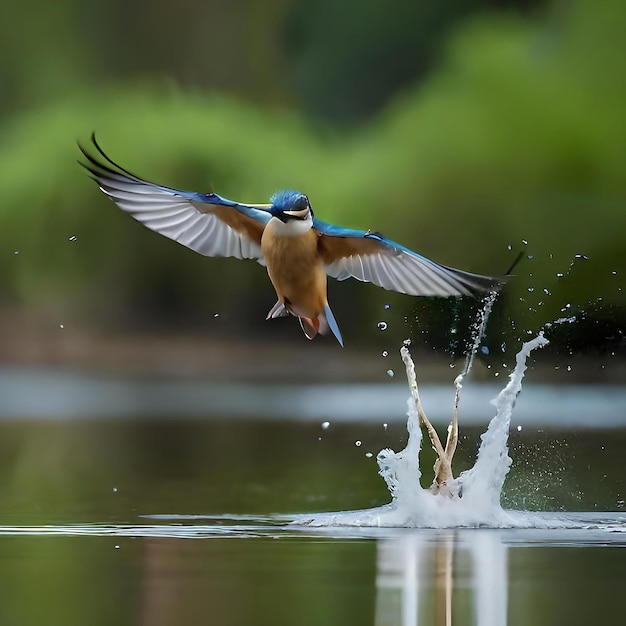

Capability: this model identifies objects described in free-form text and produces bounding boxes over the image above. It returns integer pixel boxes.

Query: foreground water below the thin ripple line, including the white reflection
[0,515,626,626]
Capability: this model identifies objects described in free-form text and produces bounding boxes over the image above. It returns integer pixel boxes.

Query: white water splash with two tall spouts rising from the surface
[298,333,557,528]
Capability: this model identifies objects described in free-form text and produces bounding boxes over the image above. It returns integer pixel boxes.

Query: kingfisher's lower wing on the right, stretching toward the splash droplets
[313,219,506,297]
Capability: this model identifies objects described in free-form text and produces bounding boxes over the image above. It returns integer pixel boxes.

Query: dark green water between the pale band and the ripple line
[0,417,626,524]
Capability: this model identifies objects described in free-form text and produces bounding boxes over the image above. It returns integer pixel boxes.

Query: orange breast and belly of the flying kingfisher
[261,222,327,318]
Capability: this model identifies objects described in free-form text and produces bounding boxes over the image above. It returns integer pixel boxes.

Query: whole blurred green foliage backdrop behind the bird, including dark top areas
[0,0,626,346]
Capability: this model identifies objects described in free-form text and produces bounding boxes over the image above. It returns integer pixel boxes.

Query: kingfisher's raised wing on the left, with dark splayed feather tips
[78,135,271,263]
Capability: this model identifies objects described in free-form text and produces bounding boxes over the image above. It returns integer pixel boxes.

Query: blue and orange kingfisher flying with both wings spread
[78,134,505,347]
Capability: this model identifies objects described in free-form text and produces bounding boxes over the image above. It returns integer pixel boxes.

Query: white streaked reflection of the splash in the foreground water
[375,530,508,626]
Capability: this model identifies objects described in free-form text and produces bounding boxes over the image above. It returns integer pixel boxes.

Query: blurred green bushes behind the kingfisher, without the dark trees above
[0,0,626,352]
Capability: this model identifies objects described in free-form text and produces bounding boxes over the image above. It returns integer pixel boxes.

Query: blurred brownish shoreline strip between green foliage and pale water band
[0,315,626,386]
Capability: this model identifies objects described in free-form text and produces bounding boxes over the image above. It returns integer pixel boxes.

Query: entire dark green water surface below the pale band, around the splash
[0,402,626,626]
